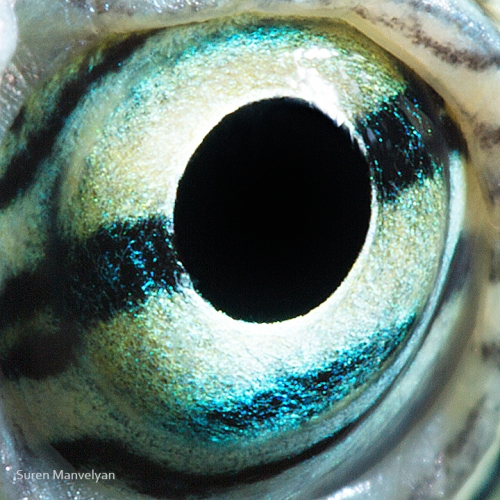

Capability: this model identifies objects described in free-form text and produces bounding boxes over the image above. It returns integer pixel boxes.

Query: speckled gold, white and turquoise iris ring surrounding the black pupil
[0,18,459,474]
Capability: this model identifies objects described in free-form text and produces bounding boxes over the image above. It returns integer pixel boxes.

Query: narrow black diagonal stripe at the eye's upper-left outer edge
[0,33,150,209]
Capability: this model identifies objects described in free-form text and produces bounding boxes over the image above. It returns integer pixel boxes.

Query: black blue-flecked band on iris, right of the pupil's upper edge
[357,83,461,200]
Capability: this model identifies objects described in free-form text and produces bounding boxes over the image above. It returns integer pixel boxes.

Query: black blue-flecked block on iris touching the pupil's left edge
[62,217,184,325]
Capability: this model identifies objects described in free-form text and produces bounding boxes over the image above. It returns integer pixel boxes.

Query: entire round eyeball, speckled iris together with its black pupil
[0,12,463,493]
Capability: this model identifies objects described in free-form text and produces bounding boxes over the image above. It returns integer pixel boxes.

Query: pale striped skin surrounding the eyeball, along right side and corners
[2,2,500,498]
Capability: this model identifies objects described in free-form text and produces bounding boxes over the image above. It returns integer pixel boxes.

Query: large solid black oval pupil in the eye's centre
[174,98,371,323]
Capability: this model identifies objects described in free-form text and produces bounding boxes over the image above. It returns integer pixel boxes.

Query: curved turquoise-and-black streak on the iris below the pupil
[190,316,415,439]
